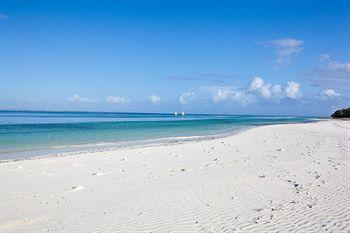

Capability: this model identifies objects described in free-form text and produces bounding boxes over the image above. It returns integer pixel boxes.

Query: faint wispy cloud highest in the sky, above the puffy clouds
[268,38,304,65]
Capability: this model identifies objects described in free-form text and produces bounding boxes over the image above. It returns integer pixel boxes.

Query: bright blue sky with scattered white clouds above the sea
[0,0,350,116]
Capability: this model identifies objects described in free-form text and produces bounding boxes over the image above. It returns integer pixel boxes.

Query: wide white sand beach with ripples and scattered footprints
[0,120,350,232]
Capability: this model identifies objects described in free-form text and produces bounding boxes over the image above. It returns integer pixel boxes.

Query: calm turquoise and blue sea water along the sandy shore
[0,111,314,159]
